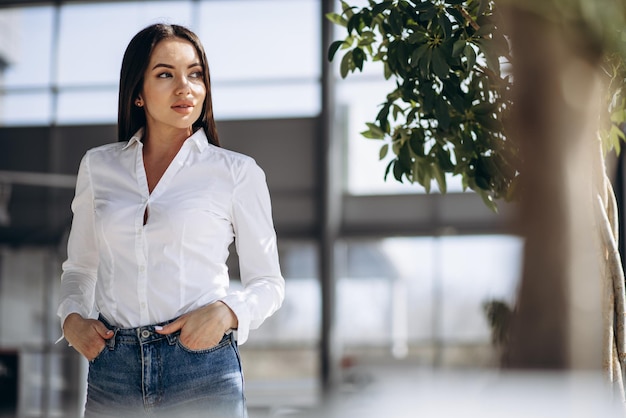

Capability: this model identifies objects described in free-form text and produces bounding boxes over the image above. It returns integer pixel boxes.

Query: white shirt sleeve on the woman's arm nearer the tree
[222,159,285,344]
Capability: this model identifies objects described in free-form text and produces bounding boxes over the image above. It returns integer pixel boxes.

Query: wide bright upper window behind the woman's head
[0,0,320,126]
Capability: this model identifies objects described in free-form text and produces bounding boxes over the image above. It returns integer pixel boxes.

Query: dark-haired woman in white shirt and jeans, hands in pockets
[58,24,284,417]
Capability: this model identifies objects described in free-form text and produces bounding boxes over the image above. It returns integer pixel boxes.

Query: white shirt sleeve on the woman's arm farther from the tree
[57,153,98,334]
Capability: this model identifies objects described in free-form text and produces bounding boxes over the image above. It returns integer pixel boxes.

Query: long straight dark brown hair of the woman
[117,23,220,146]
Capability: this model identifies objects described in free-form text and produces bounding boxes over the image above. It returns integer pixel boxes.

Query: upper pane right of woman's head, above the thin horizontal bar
[198,0,320,81]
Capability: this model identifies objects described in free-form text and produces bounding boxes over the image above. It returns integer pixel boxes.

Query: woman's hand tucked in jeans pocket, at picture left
[63,313,113,360]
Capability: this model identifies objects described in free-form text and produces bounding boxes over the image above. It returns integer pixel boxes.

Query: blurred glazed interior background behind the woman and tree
[0,0,522,418]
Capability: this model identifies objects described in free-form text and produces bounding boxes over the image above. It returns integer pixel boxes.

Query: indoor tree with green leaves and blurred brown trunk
[328,0,626,400]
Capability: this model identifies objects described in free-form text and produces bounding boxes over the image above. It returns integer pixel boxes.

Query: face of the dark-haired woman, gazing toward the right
[139,38,206,136]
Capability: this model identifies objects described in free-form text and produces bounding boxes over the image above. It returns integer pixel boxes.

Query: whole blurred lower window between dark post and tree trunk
[337,236,522,366]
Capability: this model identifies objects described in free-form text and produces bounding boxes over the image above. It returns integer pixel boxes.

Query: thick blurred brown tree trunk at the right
[504,6,603,371]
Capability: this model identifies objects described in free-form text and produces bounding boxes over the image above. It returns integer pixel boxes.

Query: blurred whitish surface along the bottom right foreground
[250,362,625,418]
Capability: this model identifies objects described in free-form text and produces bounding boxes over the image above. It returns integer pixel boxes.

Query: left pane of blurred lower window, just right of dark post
[337,238,433,350]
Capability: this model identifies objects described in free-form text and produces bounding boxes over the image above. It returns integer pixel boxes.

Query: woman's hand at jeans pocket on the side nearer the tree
[156,301,237,350]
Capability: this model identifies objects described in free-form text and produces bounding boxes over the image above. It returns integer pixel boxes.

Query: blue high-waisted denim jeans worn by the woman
[85,317,247,418]
